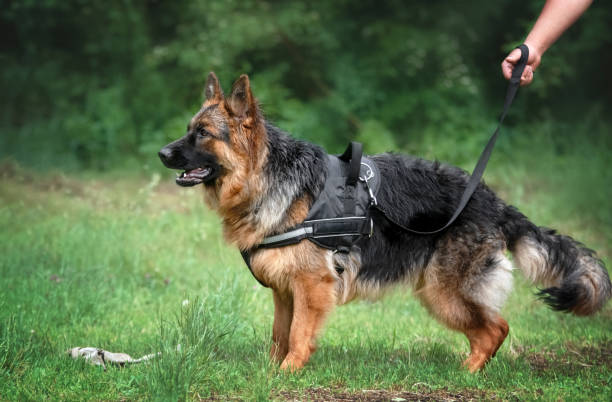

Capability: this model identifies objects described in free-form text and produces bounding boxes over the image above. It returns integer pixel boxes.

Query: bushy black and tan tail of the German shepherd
[502,207,612,315]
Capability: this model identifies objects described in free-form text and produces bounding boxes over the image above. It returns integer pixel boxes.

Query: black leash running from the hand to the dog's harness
[377,44,529,235]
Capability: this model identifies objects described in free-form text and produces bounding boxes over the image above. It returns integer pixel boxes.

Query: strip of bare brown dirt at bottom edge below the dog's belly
[277,388,501,402]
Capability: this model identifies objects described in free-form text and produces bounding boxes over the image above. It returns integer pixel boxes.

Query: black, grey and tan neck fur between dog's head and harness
[219,122,327,250]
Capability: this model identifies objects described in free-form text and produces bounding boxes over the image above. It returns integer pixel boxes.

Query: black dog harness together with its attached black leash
[241,44,529,287]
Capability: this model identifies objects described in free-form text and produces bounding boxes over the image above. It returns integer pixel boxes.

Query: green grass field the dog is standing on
[0,158,612,401]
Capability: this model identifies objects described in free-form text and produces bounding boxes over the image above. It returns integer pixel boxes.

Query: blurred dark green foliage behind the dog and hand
[0,0,612,164]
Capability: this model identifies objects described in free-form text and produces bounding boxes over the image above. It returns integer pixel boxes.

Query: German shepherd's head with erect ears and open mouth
[159,72,265,187]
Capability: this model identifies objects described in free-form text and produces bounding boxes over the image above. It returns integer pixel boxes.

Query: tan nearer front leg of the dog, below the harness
[281,268,336,371]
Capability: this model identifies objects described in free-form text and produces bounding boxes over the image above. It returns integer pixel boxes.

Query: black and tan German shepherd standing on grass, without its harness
[159,73,611,372]
